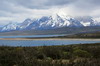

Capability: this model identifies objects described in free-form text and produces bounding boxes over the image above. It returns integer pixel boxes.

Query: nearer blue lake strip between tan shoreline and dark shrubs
[0,39,100,47]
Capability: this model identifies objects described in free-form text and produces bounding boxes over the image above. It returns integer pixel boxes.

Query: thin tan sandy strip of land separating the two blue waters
[0,38,100,41]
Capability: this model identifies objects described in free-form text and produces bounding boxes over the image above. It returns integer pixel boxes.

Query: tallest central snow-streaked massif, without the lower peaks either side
[27,14,82,29]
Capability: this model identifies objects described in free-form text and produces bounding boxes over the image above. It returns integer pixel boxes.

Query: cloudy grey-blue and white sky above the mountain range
[0,0,100,25]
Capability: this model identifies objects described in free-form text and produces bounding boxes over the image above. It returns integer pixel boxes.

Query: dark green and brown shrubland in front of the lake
[0,43,100,66]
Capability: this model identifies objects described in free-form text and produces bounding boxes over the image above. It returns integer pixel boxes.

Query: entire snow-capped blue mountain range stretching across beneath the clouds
[1,14,100,31]
